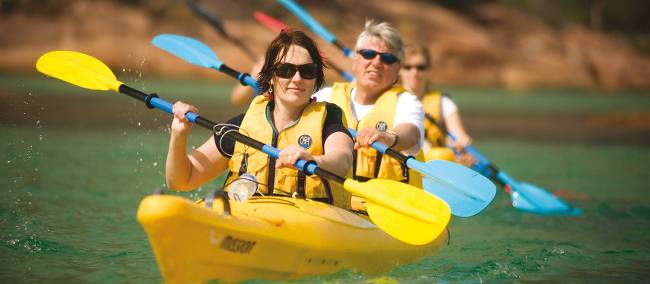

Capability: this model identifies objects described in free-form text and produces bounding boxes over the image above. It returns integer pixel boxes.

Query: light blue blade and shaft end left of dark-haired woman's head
[151,34,259,94]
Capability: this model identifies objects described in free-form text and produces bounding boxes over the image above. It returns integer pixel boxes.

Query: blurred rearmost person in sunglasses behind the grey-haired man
[400,45,475,166]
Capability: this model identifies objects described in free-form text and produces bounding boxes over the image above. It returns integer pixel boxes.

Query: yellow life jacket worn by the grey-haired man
[330,83,423,188]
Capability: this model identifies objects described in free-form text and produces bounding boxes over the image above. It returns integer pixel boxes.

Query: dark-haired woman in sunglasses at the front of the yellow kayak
[166,31,353,208]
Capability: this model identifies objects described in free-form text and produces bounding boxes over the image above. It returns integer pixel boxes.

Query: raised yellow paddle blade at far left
[36,50,122,92]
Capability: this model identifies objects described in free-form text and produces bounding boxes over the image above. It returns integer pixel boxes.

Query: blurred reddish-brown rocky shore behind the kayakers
[0,0,650,90]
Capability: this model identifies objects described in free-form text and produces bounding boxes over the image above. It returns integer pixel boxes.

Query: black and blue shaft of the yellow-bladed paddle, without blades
[119,84,345,184]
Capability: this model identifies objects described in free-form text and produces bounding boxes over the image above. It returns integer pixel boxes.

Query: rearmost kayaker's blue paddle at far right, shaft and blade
[425,114,582,216]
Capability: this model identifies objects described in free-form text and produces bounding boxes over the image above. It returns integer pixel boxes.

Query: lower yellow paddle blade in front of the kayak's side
[343,179,451,245]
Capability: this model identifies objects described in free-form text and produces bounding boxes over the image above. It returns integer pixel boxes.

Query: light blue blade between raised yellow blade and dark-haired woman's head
[151,34,223,70]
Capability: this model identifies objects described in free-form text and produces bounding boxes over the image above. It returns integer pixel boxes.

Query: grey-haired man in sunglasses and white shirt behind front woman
[315,20,424,187]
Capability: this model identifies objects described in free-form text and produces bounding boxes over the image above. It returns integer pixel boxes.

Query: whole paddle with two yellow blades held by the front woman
[36,51,451,245]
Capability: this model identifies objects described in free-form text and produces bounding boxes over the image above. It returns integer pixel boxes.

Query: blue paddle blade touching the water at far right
[510,183,582,216]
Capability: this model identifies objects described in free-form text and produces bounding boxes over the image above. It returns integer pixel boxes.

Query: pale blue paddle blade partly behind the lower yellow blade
[418,160,496,217]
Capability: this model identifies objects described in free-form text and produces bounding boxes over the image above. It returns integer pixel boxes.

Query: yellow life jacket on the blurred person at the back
[422,91,447,147]
